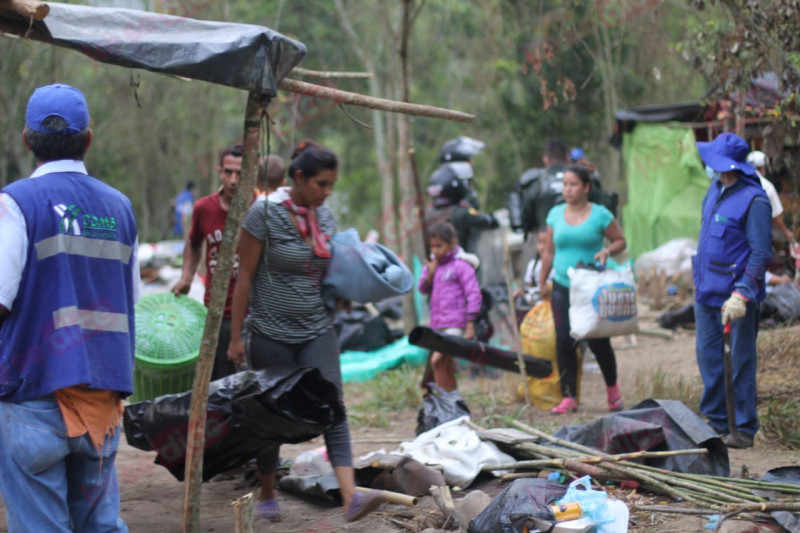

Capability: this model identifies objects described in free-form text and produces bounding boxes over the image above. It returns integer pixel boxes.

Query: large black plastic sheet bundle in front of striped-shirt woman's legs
[123,368,345,481]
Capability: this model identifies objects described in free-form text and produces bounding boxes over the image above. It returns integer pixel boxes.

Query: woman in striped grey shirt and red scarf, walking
[228,141,379,522]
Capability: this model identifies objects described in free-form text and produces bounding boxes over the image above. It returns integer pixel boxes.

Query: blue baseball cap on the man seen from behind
[25,84,89,135]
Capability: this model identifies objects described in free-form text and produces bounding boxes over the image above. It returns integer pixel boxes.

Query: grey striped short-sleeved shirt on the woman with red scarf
[242,201,336,343]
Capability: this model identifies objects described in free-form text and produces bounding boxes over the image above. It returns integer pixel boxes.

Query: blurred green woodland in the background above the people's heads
[0,0,712,240]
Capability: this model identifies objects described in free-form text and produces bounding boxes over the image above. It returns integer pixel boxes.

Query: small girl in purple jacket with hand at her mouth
[419,222,481,392]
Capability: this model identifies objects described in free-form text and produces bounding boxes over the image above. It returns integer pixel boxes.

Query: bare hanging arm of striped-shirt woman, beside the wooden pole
[228,229,264,365]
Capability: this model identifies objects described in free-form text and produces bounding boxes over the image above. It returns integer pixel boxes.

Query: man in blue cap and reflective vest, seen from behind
[0,85,139,533]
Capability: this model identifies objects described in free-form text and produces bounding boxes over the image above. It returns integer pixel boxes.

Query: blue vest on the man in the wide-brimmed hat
[692,177,766,307]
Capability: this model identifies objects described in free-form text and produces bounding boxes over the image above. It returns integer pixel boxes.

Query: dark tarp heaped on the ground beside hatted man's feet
[553,400,730,476]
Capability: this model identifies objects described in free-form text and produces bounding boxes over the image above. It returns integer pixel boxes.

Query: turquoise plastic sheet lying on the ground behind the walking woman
[341,337,428,383]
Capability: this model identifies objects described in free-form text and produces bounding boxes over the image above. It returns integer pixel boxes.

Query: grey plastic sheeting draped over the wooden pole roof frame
[34,2,306,92]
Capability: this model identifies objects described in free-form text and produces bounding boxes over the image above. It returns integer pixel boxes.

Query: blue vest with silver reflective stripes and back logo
[0,172,136,402]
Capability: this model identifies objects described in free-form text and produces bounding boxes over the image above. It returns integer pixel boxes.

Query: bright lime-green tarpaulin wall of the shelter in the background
[622,123,709,257]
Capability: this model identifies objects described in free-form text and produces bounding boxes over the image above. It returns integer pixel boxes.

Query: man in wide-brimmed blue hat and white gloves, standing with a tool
[692,133,772,448]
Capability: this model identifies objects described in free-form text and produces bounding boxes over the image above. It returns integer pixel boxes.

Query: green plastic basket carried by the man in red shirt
[131,292,207,402]
